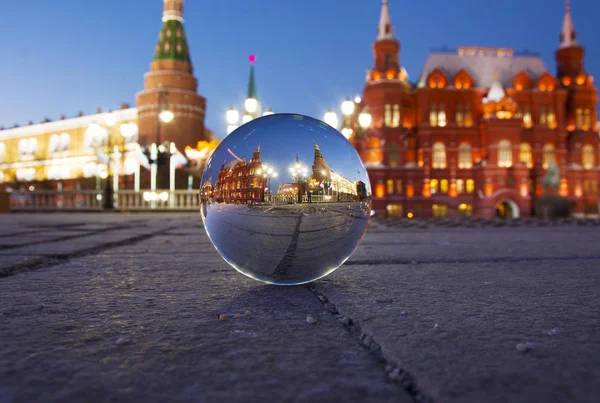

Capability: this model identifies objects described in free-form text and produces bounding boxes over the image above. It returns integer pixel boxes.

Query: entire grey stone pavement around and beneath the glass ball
[0,214,600,402]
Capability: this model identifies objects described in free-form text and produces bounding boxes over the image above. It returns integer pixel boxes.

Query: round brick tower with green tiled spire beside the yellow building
[136,0,214,150]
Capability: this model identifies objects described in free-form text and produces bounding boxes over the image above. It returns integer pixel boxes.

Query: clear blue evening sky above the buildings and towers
[0,0,600,136]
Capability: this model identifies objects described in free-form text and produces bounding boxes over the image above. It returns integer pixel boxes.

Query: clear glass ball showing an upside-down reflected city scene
[200,114,371,285]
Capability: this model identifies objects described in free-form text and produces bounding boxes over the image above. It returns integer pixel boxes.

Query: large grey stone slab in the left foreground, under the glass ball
[0,237,411,402]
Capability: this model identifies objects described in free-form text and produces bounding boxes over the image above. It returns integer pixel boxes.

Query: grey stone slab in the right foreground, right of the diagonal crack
[317,259,600,403]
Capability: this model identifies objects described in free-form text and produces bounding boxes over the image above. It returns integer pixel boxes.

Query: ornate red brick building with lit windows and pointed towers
[348,0,600,217]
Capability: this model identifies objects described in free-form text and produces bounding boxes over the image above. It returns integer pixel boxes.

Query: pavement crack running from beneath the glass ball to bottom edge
[306,283,435,403]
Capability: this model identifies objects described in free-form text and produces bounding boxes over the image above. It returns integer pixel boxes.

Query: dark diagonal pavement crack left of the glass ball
[0,226,177,278]
